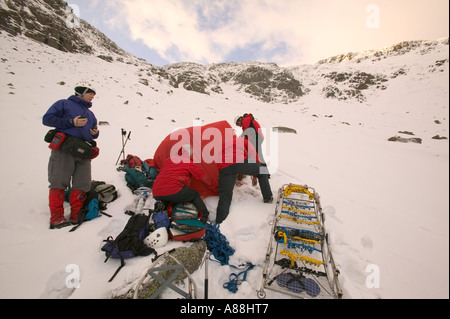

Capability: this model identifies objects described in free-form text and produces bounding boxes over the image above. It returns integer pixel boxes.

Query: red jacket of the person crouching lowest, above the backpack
[152,157,214,196]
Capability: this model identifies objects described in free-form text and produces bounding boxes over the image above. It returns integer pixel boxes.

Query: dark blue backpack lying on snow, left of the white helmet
[101,214,157,281]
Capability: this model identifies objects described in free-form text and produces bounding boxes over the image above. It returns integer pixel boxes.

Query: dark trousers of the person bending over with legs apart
[216,162,273,223]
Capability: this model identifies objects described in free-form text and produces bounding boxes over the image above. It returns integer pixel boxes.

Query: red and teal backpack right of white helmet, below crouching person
[167,203,206,241]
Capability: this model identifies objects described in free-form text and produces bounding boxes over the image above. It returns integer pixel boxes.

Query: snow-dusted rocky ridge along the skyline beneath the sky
[0,0,449,104]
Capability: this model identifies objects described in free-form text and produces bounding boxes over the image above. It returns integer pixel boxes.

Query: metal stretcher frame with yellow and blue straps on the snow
[258,184,343,299]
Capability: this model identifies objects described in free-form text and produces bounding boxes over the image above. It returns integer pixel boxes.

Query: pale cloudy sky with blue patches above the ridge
[66,0,449,66]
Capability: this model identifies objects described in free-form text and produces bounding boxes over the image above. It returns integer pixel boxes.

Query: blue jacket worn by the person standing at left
[42,95,99,141]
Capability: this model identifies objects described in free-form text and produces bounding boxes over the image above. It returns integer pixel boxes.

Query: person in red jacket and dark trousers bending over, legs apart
[216,136,273,224]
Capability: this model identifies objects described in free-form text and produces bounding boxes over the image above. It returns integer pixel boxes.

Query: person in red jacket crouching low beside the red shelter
[152,145,217,223]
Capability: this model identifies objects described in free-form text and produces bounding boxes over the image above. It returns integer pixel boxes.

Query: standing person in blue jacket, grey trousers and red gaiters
[42,82,99,229]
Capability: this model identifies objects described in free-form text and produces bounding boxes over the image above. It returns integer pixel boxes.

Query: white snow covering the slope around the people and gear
[0,33,449,299]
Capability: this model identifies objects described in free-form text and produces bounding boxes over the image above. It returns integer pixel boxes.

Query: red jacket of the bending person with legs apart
[217,136,261,170]
